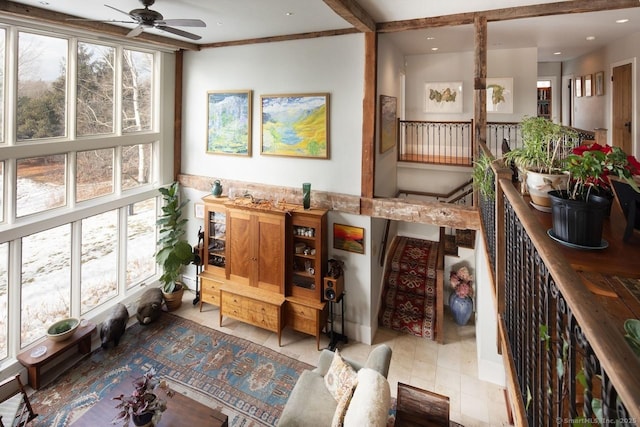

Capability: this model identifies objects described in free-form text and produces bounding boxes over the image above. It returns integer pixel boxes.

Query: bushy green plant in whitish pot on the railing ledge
[504,117,578,208]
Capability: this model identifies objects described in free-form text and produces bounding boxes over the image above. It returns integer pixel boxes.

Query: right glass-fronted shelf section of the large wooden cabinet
[287,209,327,301]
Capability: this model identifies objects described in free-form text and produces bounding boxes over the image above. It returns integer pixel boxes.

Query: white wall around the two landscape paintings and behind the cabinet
[182,34,378,343]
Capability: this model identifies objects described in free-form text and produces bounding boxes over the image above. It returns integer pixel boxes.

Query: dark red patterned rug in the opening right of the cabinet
[379,236,438,339]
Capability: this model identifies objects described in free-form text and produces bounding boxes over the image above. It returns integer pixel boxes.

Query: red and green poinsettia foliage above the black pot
[565,144,640,200]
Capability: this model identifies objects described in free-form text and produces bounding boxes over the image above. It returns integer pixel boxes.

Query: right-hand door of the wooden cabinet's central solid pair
[255,214,285,293]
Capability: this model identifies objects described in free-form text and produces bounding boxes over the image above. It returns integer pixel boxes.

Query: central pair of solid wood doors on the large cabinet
[227,208,288,295]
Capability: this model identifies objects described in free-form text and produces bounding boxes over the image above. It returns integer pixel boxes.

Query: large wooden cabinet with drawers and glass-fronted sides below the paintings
[200,196,327,349]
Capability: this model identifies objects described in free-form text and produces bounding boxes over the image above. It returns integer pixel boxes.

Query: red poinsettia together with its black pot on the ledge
[548,144,640,249]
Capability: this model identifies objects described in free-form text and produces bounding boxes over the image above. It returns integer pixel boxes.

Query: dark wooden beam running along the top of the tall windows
[0,1,199,50]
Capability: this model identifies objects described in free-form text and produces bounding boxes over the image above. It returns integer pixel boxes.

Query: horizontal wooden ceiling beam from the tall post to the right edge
[377,0,640,33]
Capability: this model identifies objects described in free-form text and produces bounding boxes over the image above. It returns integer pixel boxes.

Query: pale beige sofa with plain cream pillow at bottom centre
[278,344,391,427]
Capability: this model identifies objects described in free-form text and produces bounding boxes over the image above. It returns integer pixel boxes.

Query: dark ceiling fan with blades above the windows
[105,0,207,40]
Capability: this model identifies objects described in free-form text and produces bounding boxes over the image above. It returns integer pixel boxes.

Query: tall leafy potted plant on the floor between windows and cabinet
[156,181,195,310]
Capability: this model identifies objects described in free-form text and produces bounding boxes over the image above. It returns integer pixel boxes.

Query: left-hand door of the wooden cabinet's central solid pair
[227,209,255,285]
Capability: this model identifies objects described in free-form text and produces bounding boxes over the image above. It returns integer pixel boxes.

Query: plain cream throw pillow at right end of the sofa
[344,368,391,427]
